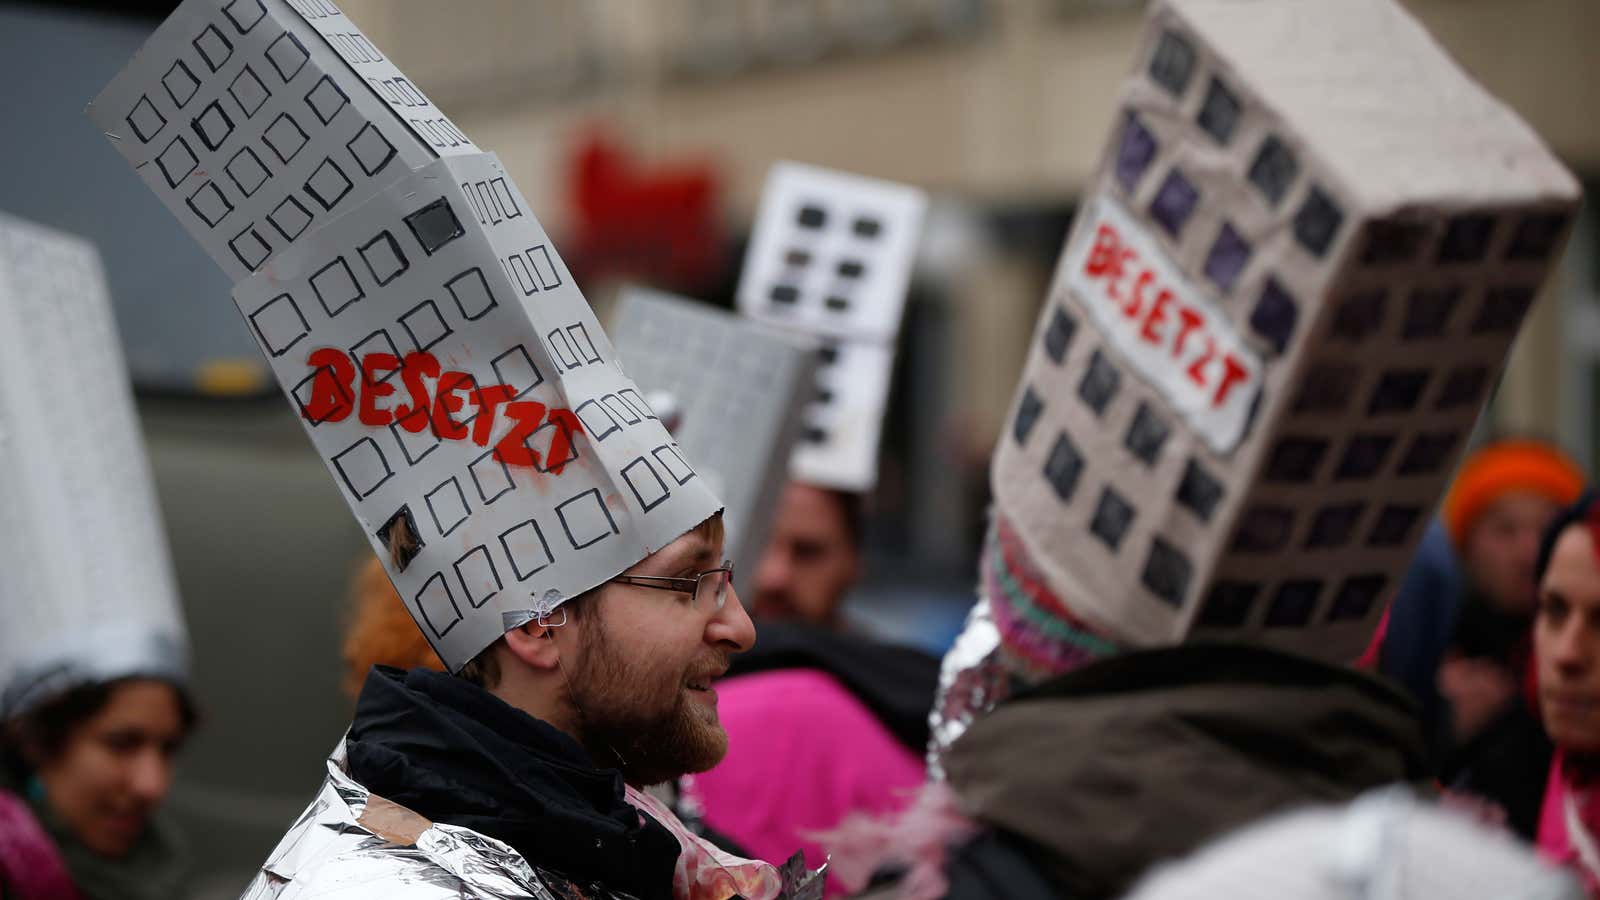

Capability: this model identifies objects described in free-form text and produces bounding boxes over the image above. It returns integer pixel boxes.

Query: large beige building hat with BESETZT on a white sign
[992,0,1579,661]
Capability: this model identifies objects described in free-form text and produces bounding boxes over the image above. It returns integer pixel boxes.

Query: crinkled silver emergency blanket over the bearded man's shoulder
[240,740,632,900]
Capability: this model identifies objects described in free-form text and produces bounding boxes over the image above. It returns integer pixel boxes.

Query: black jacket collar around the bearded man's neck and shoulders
[346,666,678,900]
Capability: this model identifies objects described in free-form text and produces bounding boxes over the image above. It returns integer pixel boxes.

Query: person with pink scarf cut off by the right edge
[1533,492,1600,897]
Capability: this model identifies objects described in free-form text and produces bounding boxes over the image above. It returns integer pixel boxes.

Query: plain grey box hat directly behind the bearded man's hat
[611,287,818,575]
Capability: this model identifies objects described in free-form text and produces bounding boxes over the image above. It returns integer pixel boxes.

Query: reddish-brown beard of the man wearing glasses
[568,611,728,786]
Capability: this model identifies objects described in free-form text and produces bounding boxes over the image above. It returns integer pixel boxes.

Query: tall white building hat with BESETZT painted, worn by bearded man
[90,0,722,671]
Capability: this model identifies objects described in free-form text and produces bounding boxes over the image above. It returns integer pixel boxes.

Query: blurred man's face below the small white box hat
[750,480,862,629]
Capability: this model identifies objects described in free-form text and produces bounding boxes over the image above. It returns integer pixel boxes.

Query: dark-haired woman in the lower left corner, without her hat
[0,676,195,900]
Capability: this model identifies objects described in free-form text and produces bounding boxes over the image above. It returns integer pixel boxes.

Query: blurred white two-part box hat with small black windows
[738,162,928,492]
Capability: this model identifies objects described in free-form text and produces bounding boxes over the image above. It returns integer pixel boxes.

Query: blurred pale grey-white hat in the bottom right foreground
[1126,788,1582,900]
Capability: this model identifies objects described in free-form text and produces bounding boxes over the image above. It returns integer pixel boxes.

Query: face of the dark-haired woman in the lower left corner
[38,679,186,857]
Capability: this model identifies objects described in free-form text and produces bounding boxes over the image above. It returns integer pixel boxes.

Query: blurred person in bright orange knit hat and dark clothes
[1382,439,1584,841]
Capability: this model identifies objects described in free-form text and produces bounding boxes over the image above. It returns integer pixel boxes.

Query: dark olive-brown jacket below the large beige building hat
[946,645,1427,898]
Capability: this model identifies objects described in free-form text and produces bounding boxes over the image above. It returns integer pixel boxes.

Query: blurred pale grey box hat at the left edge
[0,215,187,719]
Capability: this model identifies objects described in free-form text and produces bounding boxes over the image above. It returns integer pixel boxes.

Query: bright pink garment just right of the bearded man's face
[683,669,925,895]
